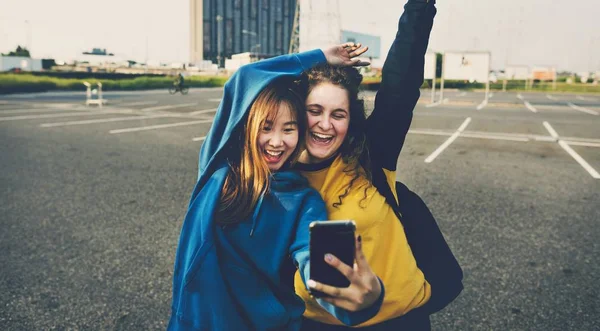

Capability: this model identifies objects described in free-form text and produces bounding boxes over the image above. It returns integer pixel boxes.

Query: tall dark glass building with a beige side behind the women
[190,0,296,66]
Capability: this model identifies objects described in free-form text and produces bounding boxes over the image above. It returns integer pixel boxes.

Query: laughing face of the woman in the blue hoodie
[256,102,298,172]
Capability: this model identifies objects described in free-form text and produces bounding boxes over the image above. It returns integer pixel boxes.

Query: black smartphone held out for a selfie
[309,220,356,297]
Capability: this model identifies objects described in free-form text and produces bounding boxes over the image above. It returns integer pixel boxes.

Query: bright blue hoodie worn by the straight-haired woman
[168,50,383,330]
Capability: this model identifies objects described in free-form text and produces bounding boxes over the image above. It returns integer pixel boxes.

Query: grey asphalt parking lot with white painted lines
[0,88,600,330]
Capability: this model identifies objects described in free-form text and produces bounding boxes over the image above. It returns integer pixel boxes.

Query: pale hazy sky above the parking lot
[0,0,600,72]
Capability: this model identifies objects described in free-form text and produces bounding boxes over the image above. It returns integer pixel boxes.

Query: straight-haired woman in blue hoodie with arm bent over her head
[168,44,384,330]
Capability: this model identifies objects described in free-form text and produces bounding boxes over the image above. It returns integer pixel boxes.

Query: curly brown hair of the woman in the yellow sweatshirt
[303,65,372,208]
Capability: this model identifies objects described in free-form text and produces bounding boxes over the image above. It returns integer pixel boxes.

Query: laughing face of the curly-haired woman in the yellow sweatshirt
[301,82,350,163]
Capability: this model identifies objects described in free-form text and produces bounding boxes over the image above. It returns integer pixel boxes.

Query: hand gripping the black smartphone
[307,236,381,311]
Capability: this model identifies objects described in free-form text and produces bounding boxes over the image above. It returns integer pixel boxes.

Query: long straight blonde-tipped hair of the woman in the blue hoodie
[216,80,306,224]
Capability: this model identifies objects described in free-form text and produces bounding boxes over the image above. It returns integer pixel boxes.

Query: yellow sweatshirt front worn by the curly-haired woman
[294,156,431,327]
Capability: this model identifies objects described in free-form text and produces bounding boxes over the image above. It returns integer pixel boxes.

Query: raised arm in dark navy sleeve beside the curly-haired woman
[367,0,436,170]
